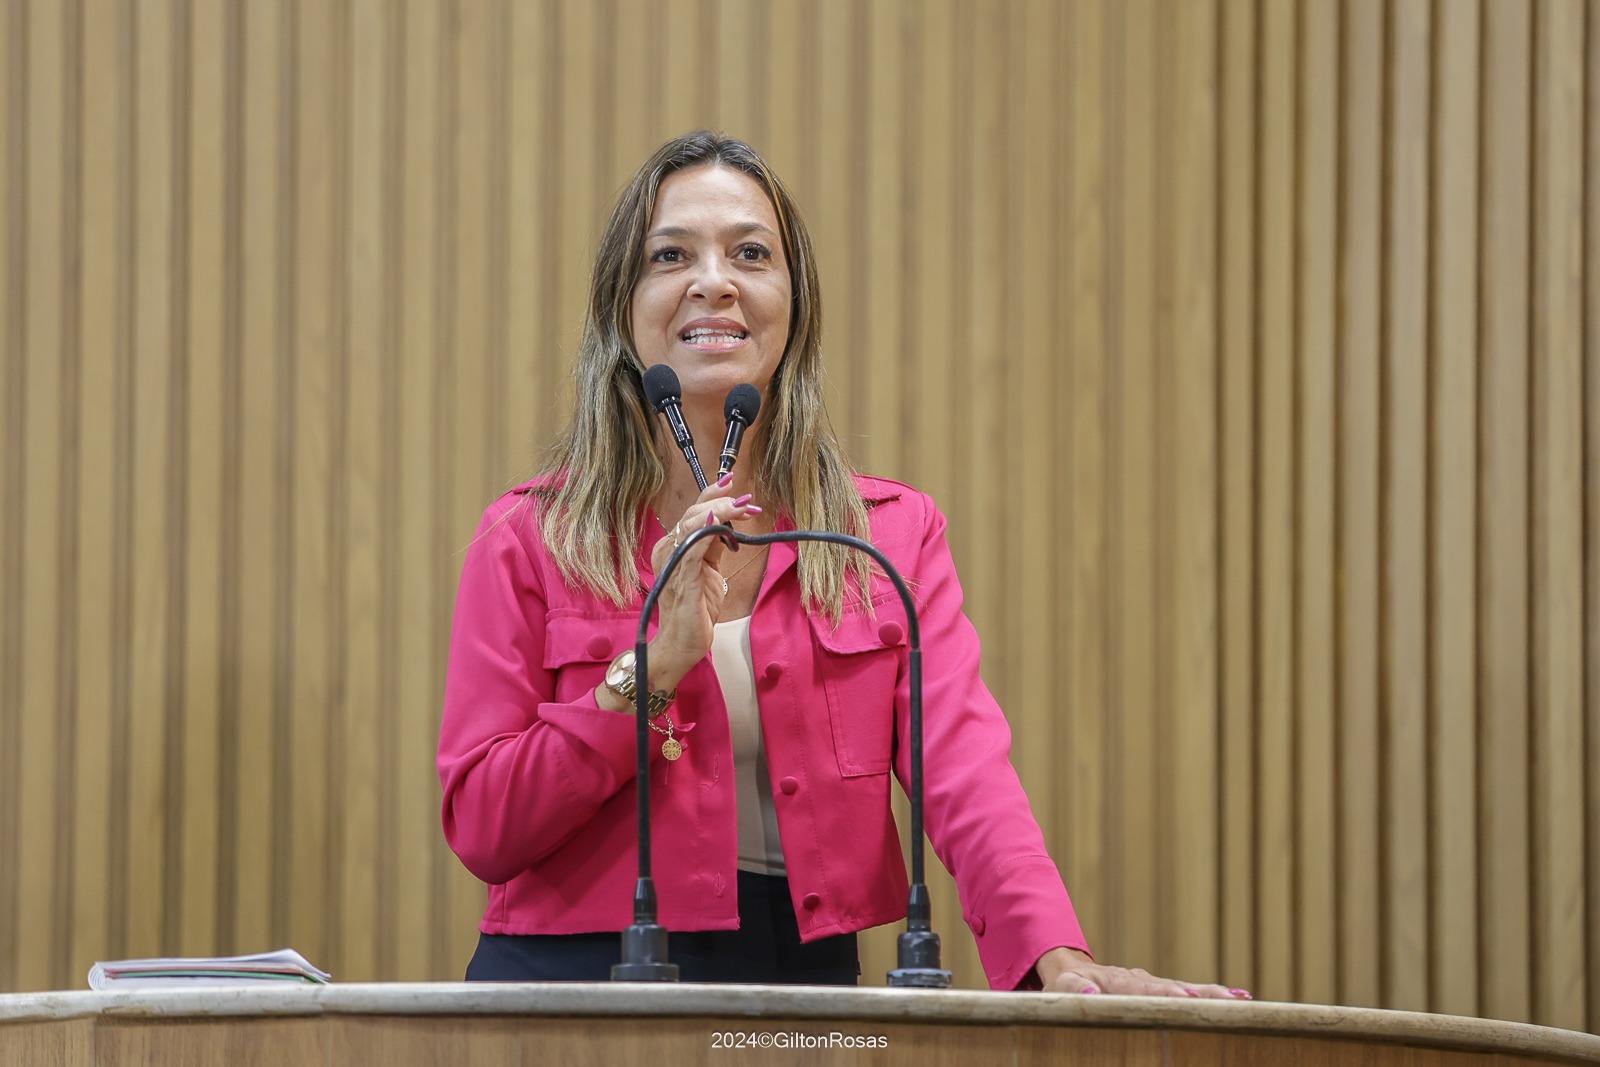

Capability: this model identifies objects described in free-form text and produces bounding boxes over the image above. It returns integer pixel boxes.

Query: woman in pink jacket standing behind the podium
[438,131,1234,997]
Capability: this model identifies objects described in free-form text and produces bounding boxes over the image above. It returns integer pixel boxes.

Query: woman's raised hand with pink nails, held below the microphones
[636,478,760,689]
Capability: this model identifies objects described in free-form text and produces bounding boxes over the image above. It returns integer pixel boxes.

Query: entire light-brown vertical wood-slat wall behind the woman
[0,0,1600,1029]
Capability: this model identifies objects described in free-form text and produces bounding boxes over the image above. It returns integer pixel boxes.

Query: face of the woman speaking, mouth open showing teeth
[630,166,790,410]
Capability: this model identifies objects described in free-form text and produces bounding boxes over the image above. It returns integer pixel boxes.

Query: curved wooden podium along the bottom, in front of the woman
[0,984,1600,1067]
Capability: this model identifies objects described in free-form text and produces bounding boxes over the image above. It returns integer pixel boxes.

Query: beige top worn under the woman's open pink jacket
[710,616,786,875]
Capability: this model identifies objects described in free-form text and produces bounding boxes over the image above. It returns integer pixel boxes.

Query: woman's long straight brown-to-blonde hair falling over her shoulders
[530,130,872,624]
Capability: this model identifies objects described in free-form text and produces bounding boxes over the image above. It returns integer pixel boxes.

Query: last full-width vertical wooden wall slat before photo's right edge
[1530,0,1594,1030]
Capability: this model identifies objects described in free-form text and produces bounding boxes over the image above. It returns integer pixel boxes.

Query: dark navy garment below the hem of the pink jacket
[467,870,861,985]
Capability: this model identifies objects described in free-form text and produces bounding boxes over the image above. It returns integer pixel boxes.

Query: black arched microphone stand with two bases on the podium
[611,526,950,989]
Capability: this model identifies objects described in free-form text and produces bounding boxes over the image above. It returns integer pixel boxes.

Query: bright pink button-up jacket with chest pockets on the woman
[438,478,1086,989]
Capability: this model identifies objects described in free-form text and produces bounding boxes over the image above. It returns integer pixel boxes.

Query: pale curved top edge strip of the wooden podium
[0,982,1600,1064]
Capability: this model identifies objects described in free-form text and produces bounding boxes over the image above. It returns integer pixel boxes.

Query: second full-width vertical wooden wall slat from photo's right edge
[1477,0,1533,1019]
